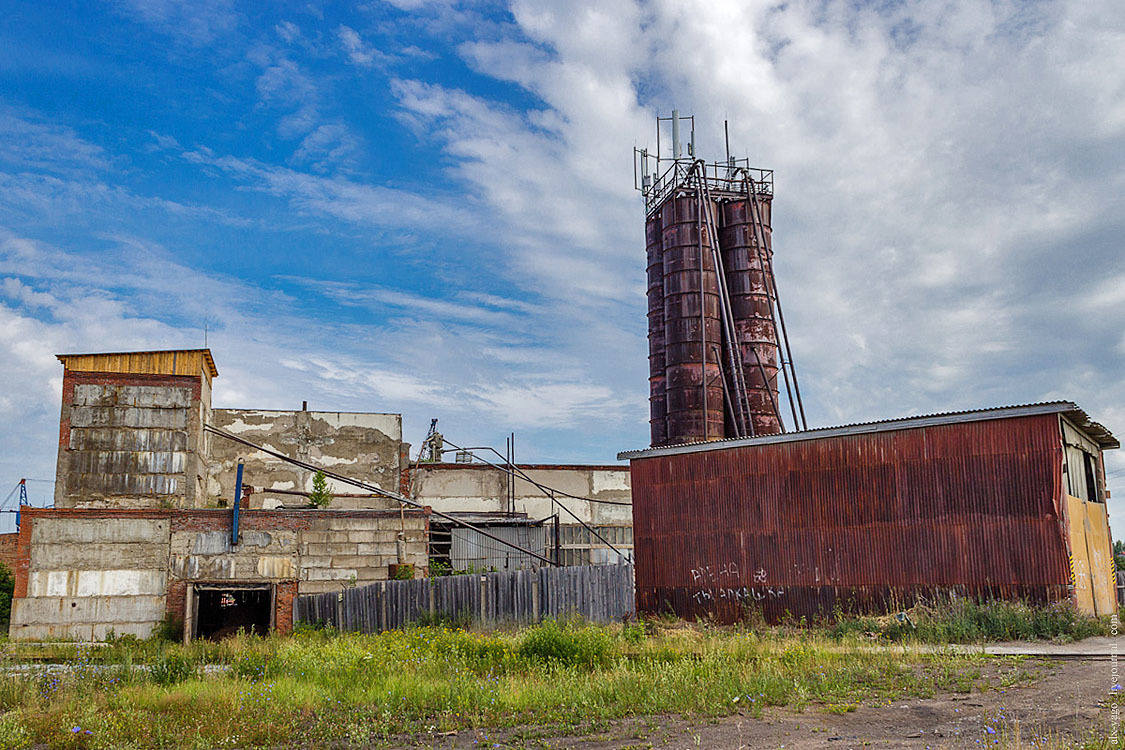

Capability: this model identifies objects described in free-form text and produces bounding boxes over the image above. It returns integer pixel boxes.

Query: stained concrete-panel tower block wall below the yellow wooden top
[55,370,210,508]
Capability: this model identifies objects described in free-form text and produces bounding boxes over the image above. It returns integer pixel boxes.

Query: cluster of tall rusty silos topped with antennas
[633,110,808,445]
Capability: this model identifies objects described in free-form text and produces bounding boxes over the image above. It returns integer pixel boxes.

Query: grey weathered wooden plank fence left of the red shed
[296,564,636,633]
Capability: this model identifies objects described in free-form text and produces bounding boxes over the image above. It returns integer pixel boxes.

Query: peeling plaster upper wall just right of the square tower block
[207,409,403,508]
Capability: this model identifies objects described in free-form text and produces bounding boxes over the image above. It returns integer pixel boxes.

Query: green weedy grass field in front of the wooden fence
[0,623,1021,749]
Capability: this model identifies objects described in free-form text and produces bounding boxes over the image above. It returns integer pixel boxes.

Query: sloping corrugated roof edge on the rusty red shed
[618,401,1121,460]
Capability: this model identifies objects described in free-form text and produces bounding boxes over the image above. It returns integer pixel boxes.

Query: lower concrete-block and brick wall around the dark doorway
[10,508,428,640]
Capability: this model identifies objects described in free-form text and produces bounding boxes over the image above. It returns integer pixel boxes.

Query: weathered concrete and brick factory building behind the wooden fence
[10,350,632,640]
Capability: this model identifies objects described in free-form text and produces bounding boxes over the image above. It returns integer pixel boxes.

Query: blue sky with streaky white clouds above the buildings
[0,0,1125,527]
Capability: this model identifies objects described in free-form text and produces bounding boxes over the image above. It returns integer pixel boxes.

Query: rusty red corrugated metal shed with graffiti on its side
[619,401,1119,622]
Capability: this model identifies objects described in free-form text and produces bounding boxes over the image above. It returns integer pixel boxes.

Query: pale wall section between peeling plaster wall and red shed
[414,463,632,525]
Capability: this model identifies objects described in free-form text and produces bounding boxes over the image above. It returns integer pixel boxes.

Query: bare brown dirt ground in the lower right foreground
[399,658,1112,750]
